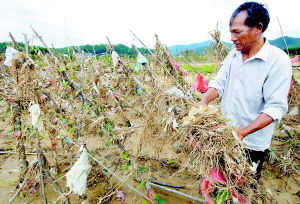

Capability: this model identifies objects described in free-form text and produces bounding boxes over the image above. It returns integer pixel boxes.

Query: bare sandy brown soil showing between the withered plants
[0,57,300,204]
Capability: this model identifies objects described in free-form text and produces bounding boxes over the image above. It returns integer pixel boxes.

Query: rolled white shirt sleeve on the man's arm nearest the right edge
[261,57,292,122]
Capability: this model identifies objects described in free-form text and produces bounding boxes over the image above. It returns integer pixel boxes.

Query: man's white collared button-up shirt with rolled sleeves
[209,40,292,151]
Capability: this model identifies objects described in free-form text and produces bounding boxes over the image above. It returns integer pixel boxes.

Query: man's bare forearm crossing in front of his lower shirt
[236,113,274,140]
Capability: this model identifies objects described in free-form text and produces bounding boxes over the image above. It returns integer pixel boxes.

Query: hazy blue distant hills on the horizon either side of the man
[169,36,300,55]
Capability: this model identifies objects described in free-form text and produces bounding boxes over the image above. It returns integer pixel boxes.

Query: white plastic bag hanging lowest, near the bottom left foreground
[66,146,92,196]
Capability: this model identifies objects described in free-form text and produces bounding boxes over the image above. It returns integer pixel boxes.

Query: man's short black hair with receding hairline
[229,2,270,32]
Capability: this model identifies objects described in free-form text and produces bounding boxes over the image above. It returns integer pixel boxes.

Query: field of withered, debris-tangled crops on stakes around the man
[0,31,300,204]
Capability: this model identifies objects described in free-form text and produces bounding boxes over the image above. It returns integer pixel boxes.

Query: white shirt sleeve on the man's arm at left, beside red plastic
[209,53,232,98]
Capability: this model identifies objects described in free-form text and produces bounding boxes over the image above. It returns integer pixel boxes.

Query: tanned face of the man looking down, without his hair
[230,11,258,53]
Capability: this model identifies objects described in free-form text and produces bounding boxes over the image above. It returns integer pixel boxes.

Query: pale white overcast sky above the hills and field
[0,0,300,48]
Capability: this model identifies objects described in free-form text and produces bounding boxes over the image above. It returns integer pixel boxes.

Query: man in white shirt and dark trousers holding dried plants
[197,2,292,180]
